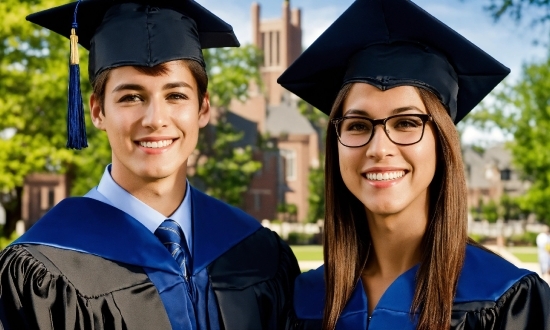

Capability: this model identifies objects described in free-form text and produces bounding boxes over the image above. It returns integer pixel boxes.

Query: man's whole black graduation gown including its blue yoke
[0,188,299,330]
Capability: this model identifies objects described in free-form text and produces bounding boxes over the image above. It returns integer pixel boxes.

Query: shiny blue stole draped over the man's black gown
[12,187,261,329]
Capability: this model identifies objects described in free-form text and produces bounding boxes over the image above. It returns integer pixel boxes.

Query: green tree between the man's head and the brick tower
[191,45,261,206]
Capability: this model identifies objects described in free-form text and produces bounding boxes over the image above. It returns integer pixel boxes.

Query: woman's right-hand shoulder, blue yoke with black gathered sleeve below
[451,246,550,330]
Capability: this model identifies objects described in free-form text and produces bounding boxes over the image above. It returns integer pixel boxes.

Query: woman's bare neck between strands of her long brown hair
[365,212,428,279]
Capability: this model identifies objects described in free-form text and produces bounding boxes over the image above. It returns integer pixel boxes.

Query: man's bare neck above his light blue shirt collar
[111,166,187,217]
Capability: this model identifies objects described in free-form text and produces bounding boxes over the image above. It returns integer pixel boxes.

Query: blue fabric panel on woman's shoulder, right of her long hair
[455,245,533,303]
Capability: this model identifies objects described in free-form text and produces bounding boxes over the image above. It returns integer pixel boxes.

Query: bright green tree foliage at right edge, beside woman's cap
[470,57,550,223]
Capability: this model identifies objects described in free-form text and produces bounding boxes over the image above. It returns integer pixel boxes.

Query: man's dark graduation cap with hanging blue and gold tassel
[27,0,239,149]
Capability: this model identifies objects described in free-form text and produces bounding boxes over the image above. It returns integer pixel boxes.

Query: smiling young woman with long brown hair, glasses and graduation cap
[279,0,550,330]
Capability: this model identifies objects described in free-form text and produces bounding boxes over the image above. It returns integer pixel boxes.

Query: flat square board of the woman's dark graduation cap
[278,0,510,122]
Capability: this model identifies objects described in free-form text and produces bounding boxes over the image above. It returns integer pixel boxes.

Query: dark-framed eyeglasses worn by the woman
[331,114,432,148]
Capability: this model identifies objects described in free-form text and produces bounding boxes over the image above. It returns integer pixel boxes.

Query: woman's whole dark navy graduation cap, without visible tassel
[277,0,510,123]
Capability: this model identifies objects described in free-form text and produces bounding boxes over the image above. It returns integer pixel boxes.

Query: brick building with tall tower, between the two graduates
[230,1,319,221]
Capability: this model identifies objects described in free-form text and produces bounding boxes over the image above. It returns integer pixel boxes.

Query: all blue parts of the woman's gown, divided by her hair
[294,245,532,330]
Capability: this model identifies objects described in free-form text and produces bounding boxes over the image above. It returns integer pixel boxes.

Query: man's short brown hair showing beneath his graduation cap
[92,59,208,115]
